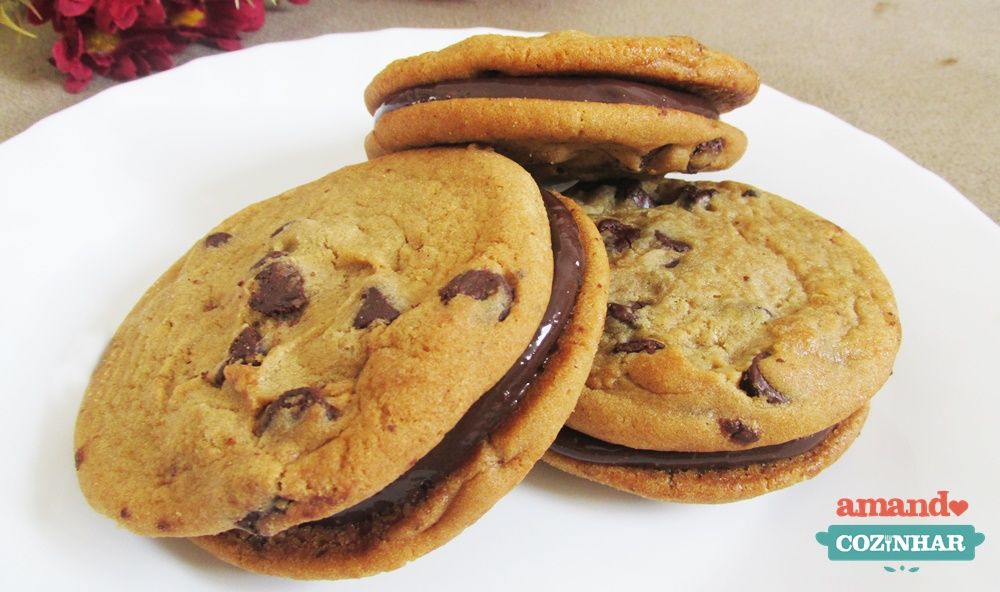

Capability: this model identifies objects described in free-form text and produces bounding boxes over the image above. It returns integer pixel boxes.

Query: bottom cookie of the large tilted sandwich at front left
[194,190,608,579]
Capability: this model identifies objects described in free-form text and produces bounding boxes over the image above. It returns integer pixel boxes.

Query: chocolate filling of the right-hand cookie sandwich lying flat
[550,426,836,470]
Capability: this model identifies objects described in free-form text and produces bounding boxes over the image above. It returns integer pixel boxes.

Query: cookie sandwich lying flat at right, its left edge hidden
[545,179,900,502]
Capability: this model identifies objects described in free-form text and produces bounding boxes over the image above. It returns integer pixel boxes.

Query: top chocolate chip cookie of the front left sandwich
[75,149,552,536]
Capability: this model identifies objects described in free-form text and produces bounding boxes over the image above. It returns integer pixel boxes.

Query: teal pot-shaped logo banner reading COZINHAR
[816,524,986,562]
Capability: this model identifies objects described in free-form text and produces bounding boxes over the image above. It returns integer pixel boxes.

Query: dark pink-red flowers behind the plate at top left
[0,0,309,92]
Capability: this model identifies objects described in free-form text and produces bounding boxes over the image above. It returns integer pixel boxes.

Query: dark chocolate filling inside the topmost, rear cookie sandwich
[375,76,719,120]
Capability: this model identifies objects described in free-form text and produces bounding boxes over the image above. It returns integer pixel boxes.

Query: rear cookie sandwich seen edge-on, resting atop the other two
[365,31,759,179]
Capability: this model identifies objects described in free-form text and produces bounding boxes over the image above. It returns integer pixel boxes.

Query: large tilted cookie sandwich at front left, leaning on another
[75,149,608,578]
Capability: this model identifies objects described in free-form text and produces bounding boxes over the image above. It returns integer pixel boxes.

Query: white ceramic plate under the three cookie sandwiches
[0,30,1000,592]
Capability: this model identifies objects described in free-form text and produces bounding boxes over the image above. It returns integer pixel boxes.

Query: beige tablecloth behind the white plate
[0,0,1000,221]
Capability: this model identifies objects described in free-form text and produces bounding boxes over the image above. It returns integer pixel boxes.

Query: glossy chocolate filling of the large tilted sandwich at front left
[302,191,585,528]
